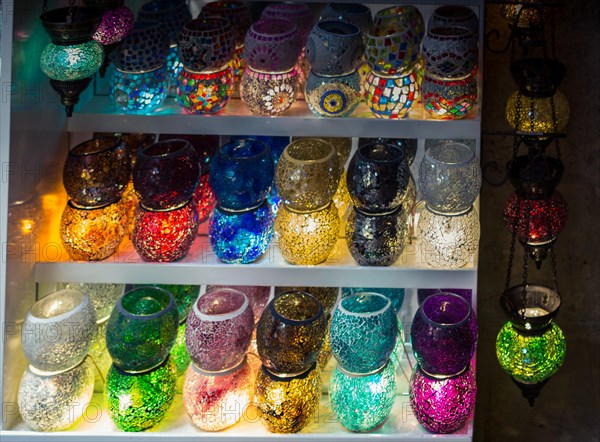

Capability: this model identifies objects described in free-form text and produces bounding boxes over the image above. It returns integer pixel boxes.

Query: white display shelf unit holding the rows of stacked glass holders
[0,0,485,442]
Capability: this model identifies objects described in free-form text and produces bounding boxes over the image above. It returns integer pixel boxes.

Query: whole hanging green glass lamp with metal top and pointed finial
[496,284,566,406]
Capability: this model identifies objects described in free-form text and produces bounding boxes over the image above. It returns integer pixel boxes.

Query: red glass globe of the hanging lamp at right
[504,190,568,245]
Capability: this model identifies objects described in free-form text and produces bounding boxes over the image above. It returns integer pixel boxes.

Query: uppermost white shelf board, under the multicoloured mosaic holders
[67,96,481,139]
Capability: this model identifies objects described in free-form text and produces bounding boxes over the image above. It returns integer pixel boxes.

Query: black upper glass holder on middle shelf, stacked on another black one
[346,141,410,214]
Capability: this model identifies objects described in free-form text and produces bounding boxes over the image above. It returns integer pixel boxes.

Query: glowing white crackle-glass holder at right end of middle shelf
[417,208,480,268]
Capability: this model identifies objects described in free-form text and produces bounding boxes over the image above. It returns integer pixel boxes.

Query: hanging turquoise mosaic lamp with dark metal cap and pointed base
[40,2,104,117]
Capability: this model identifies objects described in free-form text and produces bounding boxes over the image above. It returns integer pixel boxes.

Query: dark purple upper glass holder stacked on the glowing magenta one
[410,292,477,377]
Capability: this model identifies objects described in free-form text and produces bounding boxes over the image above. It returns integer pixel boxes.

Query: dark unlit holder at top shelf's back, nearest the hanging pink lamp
[137,0,192,44]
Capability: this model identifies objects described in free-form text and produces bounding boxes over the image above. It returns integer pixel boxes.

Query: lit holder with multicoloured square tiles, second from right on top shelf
[363,71,419,120]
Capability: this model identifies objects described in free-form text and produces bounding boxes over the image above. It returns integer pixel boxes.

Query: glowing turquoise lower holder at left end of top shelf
[108,65,169,114]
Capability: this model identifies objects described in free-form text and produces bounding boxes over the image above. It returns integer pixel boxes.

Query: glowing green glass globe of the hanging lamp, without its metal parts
[496,321,567,384]
